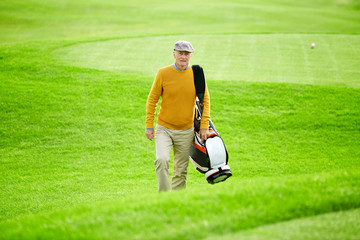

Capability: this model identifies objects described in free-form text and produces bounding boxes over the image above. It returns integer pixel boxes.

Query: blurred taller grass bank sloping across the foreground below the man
[0,170,360,239]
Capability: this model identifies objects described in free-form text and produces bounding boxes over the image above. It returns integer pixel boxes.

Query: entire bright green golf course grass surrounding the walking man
[0,0,360,240]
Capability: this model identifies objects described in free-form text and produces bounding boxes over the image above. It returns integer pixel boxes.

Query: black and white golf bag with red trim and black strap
[190,65,232,184]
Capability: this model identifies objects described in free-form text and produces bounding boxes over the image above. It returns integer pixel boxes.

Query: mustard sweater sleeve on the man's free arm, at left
[146,72,162,128]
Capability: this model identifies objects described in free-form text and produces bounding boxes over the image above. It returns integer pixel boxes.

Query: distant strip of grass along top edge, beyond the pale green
[0,0,360,43]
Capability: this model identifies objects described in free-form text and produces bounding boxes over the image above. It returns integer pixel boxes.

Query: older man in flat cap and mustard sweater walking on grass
[145,41,210,192]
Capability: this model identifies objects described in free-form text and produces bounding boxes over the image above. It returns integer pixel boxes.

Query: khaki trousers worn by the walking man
[154,124,194,192]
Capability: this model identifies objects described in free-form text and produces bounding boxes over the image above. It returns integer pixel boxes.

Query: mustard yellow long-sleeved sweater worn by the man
[146,65,210,130]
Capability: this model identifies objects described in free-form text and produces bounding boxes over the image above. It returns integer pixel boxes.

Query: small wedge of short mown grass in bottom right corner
[206,208,360,240]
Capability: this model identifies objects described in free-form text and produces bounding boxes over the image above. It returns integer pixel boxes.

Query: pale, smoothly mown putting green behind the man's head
[53,34,360,88]
